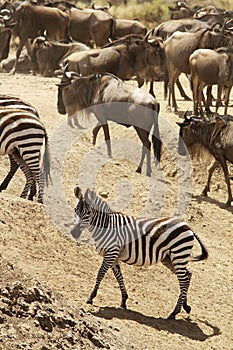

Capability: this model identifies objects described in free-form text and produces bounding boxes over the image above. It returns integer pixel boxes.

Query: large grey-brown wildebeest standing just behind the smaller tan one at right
[164,28,229,111]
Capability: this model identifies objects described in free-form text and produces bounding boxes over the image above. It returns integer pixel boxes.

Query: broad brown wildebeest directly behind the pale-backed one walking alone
[63,35,166,94]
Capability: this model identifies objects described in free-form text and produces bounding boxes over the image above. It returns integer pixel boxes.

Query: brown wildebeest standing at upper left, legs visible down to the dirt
[7,1,70,73]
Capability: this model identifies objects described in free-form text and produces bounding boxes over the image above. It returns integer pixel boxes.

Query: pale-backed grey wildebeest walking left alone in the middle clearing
[57,71,161,176]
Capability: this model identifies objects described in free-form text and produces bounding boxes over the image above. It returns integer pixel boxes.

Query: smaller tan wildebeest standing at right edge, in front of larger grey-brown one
[189,48,233,114]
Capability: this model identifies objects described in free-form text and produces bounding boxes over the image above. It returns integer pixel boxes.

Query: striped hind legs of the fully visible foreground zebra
[168,268,192,320]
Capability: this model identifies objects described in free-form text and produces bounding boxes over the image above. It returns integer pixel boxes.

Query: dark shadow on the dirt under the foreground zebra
[91,306,221,341]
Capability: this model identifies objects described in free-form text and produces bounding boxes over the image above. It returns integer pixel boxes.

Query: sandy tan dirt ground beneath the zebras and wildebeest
[0,74,233,350]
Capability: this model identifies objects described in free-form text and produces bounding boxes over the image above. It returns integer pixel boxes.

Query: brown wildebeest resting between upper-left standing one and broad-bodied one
[31,36,90,76]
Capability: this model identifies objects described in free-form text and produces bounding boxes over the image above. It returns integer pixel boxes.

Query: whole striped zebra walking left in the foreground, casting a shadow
[71,187,208,319]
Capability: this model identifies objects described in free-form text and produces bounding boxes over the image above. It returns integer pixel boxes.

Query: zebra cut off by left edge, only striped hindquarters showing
[0,95,50,203]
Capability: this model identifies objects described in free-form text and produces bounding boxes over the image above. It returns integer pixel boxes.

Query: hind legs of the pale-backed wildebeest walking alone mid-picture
[135,127,151,176]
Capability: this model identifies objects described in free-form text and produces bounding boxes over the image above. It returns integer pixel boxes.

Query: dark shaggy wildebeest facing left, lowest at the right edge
[177,115,233,206]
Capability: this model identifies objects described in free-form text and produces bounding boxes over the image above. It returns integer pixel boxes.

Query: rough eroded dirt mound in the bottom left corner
[0,258,127,350]
